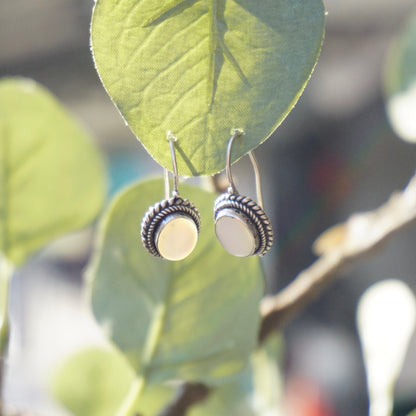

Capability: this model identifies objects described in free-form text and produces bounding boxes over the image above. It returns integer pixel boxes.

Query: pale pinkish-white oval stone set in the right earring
[215,210,257,257]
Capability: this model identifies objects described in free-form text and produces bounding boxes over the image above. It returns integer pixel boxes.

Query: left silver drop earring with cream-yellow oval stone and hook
[141,132,201,261]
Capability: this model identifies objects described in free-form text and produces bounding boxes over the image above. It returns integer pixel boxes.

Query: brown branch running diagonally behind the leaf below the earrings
[159,176,416,416]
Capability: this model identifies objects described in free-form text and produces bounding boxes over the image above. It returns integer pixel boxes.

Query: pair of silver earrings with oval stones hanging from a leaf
[141,130,273,261]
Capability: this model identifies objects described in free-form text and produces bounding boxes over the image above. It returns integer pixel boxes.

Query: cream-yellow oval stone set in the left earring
[156,214,198,261]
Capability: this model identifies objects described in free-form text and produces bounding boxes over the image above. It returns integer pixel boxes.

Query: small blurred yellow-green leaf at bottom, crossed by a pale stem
[51,347,174,416]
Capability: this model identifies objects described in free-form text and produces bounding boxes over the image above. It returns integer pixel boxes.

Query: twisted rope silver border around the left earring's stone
[141,195,201,257]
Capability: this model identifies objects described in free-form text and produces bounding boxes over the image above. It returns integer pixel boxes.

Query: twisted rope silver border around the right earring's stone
[214,193,273,257]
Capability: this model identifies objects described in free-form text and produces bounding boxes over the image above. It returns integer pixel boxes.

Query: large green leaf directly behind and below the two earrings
[88,180,263,384]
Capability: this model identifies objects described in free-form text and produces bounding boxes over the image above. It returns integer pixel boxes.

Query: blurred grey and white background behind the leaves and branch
[0,0,416,416]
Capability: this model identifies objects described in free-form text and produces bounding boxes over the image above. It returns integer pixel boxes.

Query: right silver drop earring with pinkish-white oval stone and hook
[214,130,273,257]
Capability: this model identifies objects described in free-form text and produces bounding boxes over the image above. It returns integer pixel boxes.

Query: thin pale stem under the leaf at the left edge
[0,257,14,416]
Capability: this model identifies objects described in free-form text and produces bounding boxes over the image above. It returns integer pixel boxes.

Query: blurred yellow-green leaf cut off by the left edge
[0,78,105,265]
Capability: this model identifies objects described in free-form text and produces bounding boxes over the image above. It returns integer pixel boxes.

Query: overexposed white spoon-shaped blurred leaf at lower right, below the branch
[357,279,416,416]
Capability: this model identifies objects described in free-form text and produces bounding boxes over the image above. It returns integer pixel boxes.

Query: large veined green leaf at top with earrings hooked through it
[91,0,324,176]
